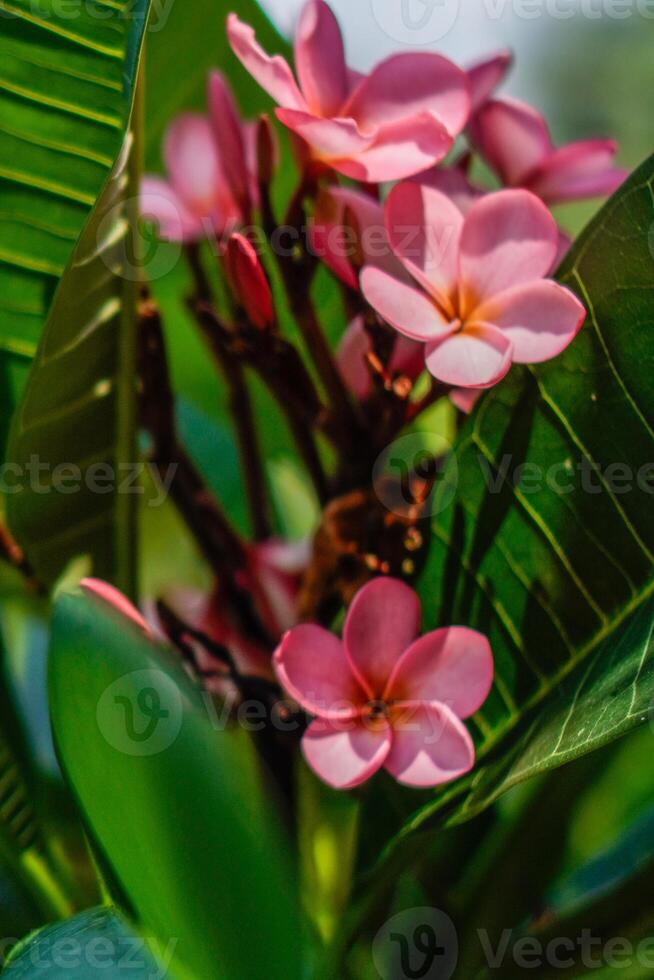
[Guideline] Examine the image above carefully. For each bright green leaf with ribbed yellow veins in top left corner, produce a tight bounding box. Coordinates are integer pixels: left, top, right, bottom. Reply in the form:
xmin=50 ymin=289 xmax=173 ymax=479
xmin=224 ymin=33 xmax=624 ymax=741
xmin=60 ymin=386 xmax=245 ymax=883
xmin=0 ymin=0 xmax=148 ymax=448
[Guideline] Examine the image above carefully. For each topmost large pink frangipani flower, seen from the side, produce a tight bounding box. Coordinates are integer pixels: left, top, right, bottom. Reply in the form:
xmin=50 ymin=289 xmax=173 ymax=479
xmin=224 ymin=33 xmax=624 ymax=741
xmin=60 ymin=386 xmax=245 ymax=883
xmin=227 ymin=0 xmax=470 ymax=182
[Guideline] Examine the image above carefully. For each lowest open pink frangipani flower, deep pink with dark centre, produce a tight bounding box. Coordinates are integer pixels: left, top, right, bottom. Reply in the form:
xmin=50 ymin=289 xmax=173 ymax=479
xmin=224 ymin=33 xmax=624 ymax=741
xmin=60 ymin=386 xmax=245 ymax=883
xmin=273 ymin=578 xmax=493 ymax=789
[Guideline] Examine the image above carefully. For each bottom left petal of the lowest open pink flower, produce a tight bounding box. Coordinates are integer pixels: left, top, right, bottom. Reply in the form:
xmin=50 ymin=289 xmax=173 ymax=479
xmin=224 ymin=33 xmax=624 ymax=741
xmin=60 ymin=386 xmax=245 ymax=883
xmin=302 ymin=718 xmax=392 ymax=789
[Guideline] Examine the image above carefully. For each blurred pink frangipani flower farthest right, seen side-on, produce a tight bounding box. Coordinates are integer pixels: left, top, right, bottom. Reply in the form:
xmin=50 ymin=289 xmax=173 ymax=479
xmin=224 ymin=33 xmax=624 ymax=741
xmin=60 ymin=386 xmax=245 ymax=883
xmin=470 ymin=99 xmax=627 ymax=204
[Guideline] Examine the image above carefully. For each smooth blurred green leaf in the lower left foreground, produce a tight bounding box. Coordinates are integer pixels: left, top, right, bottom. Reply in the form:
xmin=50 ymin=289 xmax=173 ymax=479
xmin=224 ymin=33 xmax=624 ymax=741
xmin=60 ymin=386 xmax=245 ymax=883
xmin=50 ymin=595 xmax=300 ymax=980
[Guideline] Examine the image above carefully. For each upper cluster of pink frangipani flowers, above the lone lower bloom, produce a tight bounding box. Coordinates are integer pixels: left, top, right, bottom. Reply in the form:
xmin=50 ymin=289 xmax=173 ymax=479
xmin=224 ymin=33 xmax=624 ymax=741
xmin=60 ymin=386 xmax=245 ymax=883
xmin=143 ymin=0 xmax=625 ymax=405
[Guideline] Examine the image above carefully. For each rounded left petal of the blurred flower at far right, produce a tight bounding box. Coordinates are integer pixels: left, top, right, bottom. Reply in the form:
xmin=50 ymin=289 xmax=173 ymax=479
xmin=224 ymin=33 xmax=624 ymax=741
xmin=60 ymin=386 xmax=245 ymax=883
xmin=470 ymin=99 xmax=552 ymax=186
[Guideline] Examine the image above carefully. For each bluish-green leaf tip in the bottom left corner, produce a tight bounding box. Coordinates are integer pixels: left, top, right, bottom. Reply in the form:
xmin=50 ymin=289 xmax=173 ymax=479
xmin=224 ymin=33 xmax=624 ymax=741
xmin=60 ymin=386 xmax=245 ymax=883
xmin=2 ymin=908 xmax=173 ymax=980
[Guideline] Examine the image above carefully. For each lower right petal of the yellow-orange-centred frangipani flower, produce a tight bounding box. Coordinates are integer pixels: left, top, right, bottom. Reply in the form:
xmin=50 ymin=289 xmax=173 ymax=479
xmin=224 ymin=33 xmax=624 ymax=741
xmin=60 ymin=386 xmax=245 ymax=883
xmin=474 ymin=279 xmax=586 ymax=364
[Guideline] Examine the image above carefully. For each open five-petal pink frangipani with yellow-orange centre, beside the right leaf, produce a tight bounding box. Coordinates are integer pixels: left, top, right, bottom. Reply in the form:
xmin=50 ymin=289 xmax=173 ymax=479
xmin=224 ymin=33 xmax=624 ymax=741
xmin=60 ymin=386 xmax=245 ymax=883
xmin=361 ymin=181 xmax=586 ymax=388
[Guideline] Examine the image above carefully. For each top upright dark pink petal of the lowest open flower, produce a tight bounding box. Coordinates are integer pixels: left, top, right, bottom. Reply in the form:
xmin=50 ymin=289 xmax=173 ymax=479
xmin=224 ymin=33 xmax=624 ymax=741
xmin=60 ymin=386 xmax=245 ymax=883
xmin=343 ymin=578 xmax=420 ymax=698
